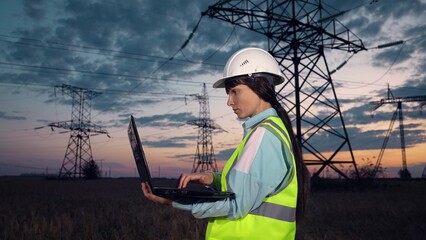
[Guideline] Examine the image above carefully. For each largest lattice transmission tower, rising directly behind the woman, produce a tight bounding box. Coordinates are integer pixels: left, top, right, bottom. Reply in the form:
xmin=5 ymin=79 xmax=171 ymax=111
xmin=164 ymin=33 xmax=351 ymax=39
xmin=202 ymin=0 xmax=366 ymax=178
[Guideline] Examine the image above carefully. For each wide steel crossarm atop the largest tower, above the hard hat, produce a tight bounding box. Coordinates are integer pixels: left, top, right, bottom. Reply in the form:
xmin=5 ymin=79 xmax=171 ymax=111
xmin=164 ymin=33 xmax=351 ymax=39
xmin=202 ymin=0 xmax=367 ymax=53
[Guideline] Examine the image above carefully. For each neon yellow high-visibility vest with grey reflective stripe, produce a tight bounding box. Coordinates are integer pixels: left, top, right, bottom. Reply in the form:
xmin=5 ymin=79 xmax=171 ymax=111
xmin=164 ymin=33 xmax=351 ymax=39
xmin=206 ymin=116 xmax=297 ymax=240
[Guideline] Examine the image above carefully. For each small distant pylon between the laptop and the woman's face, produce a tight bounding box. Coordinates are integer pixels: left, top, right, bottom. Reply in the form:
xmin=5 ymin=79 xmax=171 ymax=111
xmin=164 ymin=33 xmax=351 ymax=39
xmin=187 ymin=83 xmax=220 ymax=173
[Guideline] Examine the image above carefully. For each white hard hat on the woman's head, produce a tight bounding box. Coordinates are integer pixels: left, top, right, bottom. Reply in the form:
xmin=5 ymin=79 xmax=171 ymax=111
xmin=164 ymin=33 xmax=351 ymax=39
xmin=213 ymin=48 xmax=284 ymax=88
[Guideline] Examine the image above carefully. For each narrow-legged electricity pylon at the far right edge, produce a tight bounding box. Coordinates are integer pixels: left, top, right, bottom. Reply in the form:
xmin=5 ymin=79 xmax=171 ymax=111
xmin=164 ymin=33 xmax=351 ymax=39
xmin=370 ymin=86 xmax=426 ymax=178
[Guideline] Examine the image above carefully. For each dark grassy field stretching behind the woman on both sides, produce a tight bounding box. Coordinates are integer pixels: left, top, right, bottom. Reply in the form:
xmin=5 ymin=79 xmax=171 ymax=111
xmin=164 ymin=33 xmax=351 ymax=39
xmin=0 ymin=177 xmax=426 ymax=239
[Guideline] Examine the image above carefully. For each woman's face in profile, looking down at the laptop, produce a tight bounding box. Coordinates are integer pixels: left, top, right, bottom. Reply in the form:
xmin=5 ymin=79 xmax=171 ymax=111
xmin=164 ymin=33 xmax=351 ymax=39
xmin=227 ymin=84 xmax=271 ymax=119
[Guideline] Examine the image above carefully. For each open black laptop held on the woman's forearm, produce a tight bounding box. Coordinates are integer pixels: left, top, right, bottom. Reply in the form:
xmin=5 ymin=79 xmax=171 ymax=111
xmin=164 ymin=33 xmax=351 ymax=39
xmin=127 ymin=116 xmax=234 ymax=202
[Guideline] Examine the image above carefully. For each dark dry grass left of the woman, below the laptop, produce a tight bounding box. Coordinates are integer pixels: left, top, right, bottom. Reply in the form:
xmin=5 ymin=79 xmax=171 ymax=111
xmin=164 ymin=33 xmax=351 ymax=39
xmin=0 ymin=178 xmax=204 ymax=239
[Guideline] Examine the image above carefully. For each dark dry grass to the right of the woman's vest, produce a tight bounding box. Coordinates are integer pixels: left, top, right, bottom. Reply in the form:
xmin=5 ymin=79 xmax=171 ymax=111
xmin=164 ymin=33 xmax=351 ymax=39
xmin=300 ymin=180 xmax=426 ymax=240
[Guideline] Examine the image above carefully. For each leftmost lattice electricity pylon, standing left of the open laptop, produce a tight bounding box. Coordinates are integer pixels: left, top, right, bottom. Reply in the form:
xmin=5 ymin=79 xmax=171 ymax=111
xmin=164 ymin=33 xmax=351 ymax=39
xmin=48 ymin=84 xmax=109 ymax=178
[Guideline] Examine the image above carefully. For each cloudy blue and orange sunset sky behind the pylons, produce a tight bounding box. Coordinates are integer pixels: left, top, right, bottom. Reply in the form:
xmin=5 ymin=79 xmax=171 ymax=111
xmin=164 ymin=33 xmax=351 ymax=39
xmin=0 ymin=0 xmax=426 ymax=177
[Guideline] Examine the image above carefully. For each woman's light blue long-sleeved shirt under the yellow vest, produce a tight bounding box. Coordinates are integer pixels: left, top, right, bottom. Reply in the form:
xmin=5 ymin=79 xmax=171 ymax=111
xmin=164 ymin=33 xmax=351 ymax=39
xmin=173 ymin=108 xmax=291 ymax=219
